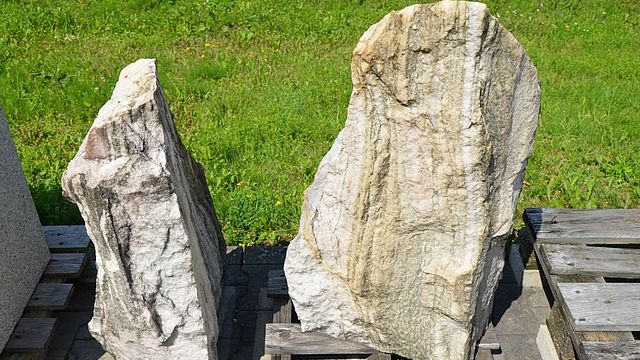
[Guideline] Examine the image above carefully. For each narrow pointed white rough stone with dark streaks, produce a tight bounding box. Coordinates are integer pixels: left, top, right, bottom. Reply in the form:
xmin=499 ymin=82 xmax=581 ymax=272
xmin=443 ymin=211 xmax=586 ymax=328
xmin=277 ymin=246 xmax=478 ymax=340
xmin=62 ymin=59 xmax=225 ymax=359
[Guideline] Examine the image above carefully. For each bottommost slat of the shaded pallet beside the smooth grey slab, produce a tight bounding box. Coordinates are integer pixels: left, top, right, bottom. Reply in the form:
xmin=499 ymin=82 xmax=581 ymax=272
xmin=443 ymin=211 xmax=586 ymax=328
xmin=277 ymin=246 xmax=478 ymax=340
xmin=4 ymin=318 xmax=56 ymax=353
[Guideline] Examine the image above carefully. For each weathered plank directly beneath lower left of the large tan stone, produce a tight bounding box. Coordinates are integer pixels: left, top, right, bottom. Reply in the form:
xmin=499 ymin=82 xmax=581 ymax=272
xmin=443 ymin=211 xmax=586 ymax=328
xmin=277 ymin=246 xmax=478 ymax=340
xmin=264 ymin=324 xmax=375 ymax=355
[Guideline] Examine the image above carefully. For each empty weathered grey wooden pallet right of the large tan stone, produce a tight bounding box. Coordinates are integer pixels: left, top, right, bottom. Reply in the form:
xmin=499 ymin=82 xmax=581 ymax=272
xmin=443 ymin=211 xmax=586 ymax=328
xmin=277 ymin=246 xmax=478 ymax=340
xmin=524 ymin=209 xmax=640 ymax=360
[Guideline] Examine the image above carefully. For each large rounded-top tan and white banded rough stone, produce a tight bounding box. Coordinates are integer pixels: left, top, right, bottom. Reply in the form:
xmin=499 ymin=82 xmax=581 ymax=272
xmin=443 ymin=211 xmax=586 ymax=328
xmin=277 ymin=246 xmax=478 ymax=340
xmin=285 ymin=2 xmax=540 ymax=359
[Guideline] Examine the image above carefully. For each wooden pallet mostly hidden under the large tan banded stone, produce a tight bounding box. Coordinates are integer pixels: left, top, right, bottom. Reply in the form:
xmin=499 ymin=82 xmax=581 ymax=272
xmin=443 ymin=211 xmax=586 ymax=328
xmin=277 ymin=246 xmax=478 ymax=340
xmin=265 ymin=270 xmax=500 ymax=360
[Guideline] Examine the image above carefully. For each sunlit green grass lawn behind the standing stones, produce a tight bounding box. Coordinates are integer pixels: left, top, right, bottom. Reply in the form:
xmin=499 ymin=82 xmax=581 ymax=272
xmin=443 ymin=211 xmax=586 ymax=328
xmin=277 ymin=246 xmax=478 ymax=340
xmin=0 ymin=0 xmax=640 ymax=244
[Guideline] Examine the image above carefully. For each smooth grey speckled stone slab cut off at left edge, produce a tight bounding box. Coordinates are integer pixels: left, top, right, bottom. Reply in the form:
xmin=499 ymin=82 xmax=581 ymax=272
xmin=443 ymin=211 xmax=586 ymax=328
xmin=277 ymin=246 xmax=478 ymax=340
xmin=0 ymin=109 xmax=49 ymax=352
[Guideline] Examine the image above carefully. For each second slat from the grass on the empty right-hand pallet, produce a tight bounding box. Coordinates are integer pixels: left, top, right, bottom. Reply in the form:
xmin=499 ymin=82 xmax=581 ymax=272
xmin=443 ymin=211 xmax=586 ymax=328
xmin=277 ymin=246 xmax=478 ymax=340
xmin=541 ymin=244 xmax=640 ymax=279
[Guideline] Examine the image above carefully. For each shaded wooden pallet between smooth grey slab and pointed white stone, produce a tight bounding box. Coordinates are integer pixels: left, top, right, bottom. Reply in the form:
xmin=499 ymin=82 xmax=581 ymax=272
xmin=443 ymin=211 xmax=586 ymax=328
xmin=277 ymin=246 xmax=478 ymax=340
xmin=0 ymin=225 xmax=89 ymax=360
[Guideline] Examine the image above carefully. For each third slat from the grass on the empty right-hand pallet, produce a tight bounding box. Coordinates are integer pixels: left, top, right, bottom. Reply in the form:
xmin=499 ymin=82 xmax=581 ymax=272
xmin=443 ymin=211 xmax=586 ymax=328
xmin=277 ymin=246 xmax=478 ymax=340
xmin=558 ymin=283 xmax=640 ymax=331
